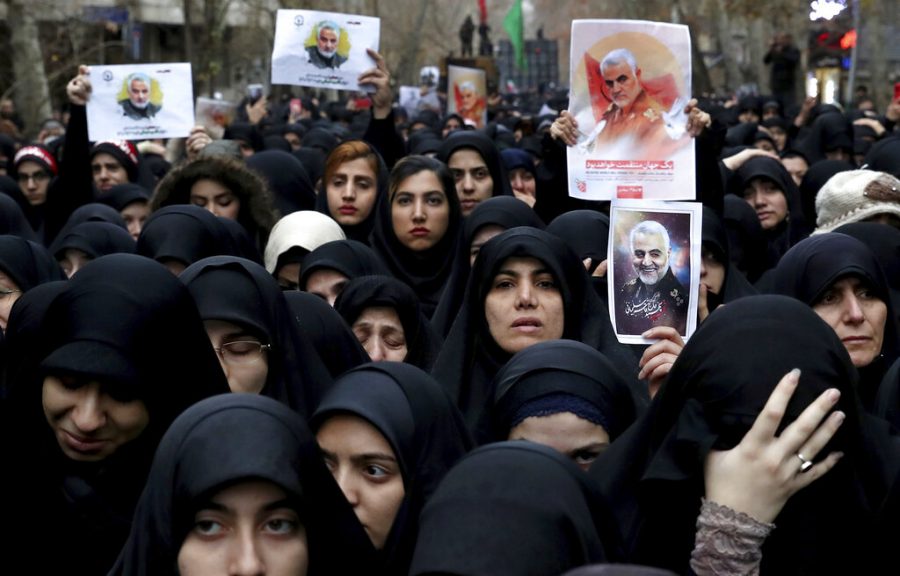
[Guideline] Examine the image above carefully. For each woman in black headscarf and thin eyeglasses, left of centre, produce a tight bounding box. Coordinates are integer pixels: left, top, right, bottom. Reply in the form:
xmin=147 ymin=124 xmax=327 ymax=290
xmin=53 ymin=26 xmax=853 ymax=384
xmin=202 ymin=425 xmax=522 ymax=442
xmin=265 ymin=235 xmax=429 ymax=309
xmin=179 ymin=256 xmax=331 ymax=416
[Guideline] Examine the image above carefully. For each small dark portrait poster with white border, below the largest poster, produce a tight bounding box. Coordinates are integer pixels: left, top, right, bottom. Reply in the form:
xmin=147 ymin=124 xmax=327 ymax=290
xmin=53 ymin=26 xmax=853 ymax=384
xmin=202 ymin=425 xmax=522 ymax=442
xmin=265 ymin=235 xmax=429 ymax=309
xmin=607 ymin=199 xmax=703 ymax=344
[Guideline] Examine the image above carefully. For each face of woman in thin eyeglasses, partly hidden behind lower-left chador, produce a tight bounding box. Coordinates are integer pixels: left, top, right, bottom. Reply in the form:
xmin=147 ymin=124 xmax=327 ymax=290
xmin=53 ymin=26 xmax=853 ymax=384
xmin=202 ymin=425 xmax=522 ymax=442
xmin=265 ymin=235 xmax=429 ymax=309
xmin=203 ymin=320 xmax=269 ymax=394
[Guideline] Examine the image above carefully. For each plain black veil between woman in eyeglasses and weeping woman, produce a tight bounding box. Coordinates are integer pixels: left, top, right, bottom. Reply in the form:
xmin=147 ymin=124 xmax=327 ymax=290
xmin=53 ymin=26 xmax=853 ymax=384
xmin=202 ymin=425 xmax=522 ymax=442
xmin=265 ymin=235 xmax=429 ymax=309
xmin=284 ymin=290 xmax=369 ymax=378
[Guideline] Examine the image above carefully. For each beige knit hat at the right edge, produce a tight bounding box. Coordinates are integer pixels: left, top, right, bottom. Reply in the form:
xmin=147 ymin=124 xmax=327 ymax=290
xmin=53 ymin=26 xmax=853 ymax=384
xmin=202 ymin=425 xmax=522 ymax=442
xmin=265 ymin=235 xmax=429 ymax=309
xmin=813 ymin=170 xmax=900 ymax=234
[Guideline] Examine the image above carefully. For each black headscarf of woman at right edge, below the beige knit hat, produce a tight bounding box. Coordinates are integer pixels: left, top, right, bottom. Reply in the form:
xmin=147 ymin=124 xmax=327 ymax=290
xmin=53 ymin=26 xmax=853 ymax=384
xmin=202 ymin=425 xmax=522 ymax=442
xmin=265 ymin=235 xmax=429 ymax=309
xmin=772 ymin=232 xmax=900 ymax=409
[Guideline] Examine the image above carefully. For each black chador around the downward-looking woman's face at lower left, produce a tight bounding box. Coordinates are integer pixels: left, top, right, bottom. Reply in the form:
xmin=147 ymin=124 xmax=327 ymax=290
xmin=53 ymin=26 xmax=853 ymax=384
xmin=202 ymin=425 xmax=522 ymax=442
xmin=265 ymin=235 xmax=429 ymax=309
xmin=0 ymin=254 xmax=228 ymax=574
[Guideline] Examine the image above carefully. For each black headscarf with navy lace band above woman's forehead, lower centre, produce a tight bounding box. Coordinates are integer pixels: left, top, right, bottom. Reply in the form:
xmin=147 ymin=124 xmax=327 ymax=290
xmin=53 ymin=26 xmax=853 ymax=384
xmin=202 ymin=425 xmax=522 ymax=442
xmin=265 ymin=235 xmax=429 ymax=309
xmin=476 ymin=340 xmax=637 ymax=444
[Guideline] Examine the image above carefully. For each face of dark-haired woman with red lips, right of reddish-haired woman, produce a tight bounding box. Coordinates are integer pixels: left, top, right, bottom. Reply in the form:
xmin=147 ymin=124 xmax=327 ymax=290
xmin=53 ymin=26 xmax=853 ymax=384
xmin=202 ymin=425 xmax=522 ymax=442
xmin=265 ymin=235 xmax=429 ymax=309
xmin=391 ymin=170 xmax=450 ymax=252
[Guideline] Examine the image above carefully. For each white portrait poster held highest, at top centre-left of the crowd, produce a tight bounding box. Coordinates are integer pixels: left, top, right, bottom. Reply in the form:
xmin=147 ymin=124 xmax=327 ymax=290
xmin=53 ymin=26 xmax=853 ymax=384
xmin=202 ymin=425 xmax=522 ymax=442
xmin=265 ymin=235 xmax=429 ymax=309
xmin=272 ymin=10 xmax=381 ymax=92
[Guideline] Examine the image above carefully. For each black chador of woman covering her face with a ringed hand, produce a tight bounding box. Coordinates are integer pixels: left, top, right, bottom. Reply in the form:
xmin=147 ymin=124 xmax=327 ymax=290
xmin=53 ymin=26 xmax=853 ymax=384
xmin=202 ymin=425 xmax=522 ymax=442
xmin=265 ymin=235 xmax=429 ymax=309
xmin=590 ymin=296 xmax=898 ymax=574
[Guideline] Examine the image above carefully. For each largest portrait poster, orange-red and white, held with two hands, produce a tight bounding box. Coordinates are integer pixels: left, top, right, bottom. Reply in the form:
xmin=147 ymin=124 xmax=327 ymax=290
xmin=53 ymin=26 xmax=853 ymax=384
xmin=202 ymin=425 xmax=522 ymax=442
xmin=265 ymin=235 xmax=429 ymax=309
xmin=567 ymin=20 xmax=696 ymax=200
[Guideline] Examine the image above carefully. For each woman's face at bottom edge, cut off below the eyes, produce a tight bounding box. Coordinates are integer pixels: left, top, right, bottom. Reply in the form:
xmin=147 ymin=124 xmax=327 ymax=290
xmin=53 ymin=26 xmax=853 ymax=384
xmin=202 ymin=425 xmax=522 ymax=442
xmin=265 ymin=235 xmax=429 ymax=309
xmin=178 ymin=480 xmax=309 ymax=576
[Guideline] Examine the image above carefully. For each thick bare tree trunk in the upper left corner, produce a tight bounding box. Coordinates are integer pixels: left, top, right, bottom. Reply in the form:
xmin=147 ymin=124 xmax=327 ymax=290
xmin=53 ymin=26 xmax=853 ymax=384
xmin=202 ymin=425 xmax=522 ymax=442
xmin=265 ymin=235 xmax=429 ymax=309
xmin=7 ymin=0 xmax=51 ymax=136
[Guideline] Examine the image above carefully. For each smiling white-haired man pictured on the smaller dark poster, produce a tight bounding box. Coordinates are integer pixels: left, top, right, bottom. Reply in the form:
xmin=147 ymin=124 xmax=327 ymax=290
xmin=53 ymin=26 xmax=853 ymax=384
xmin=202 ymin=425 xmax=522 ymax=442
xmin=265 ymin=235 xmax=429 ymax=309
xmin=616 ymin=220 xmax=688 ymax=334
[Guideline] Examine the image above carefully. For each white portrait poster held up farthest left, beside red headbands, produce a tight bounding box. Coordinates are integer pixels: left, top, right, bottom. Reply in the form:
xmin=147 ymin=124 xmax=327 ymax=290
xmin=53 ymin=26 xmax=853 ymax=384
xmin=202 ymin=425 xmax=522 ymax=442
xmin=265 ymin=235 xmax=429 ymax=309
xmin=87 ymin=63 xmax=194 ymax=142
